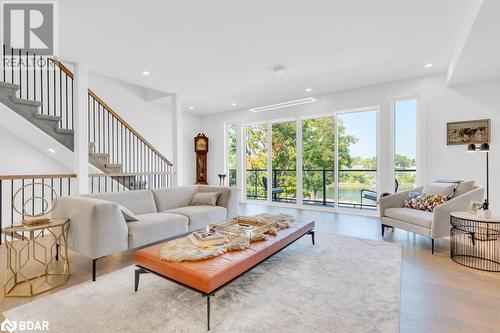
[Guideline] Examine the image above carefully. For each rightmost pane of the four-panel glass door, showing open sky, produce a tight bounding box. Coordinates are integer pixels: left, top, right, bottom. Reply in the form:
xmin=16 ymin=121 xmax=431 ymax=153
xmin=337 ymin=110 xmax=377 ymax=209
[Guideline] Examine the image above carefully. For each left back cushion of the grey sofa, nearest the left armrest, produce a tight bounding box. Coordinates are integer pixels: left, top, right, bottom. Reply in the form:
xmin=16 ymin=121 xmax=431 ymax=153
xmin=82 ymin=190 xmax=157 ymax=214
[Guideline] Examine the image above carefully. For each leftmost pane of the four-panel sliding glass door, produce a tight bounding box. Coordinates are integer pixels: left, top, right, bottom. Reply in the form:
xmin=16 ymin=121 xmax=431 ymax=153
xmin=245 ymin=123 xmax=268 ymax=200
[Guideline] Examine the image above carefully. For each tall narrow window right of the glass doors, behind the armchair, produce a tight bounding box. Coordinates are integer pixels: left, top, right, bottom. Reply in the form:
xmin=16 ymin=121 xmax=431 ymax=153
xmin=394 ymin=98 xmax=417 ymax=191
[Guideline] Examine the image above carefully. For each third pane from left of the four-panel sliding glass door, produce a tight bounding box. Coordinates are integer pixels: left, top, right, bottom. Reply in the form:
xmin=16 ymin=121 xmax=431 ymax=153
xmin=302 ymin=117 xmax=335 ymax=207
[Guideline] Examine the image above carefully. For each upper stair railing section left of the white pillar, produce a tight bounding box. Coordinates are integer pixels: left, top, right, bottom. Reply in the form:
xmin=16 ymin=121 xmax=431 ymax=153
xmin=1 ymin=44 xmax=74 ymax=130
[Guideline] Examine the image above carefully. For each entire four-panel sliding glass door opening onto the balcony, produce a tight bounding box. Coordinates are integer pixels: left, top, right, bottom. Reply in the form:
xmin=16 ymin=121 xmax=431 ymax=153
xmin=244 ymin=109 xmax=378 ymax=210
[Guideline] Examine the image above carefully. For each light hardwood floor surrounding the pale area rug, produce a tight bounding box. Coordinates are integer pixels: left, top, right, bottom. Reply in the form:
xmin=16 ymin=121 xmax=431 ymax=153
xmin=0 ymin=204 xmax=500 ymax=333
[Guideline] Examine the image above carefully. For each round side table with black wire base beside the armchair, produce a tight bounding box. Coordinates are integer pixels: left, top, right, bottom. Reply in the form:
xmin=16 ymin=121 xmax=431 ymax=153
xmin=450 ymin=212 xmax=500 ymax=272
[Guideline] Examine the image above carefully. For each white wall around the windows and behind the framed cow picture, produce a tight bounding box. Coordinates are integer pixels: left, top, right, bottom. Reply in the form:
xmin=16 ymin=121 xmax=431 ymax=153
xmin=201 ymin=74 xmax=500 ymax=209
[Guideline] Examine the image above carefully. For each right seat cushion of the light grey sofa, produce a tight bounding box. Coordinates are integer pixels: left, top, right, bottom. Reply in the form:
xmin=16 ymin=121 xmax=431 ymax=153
xmin=165 ymin=206 xmax=227 ymax=230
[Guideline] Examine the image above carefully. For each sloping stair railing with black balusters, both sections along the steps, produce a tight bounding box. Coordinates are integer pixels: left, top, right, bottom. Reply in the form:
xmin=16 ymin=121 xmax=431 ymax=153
xmin=1 ymin=45 xmax=173 ymax=192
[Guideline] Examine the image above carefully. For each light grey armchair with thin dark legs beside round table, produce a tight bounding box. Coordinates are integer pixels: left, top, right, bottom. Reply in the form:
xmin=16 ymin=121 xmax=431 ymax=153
xmin=379 ymin=182 xmax=484 ymax=254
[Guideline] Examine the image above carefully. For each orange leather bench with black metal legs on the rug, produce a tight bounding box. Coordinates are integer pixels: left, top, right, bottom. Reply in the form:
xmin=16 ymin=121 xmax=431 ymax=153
xmin=134 ymin=221 xmax=314 ymax=330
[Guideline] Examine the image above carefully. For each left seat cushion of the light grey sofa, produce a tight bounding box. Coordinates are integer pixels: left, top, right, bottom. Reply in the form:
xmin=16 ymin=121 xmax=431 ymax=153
xmin=127 ymin=213 xmax=189 ymax=249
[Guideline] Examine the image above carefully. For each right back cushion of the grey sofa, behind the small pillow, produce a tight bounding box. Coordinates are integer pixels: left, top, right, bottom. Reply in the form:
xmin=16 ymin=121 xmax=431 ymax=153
xmin=151 ymin=186 xmax=198 ymax=212
